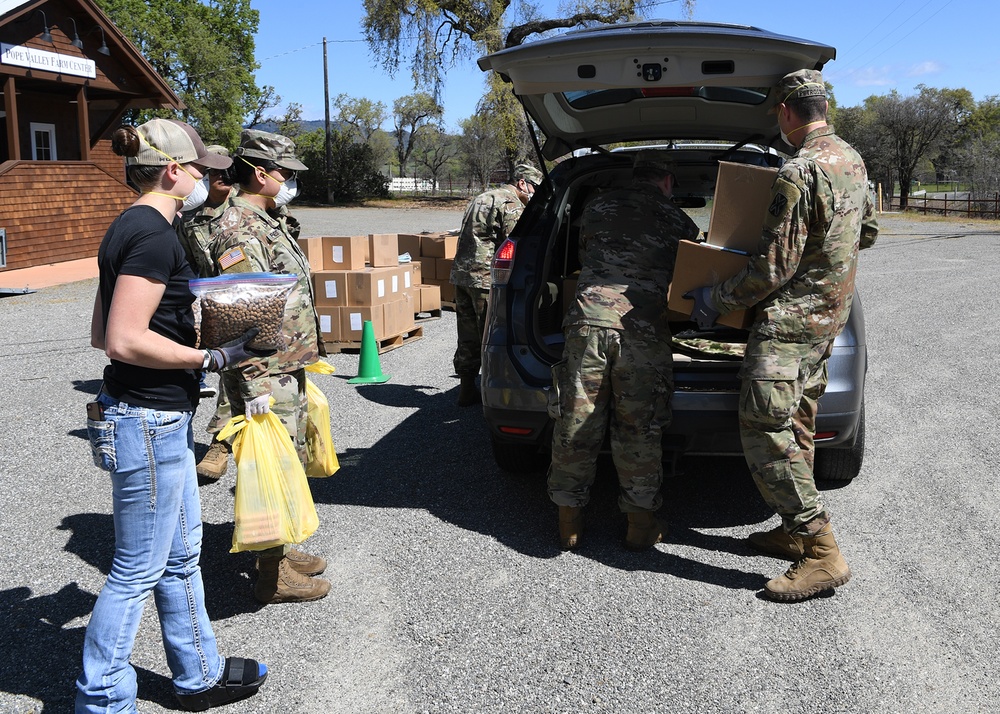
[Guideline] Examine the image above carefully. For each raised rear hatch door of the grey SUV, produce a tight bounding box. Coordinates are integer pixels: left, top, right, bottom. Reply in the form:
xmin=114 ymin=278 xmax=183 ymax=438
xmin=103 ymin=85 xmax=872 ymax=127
xmin=478 ymin=20 xmax=837 ymax=160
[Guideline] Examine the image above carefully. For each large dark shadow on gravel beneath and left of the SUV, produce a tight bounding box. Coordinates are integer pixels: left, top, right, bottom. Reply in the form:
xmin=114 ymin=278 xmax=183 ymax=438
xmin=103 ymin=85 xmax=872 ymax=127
xmin=310 ymin=383 xmax=772 ymax=589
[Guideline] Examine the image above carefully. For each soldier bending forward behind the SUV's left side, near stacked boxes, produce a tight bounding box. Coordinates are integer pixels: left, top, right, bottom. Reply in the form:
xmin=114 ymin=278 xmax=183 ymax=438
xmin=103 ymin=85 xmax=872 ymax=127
xmin=451 ymin=164 xmax=542 ymax=407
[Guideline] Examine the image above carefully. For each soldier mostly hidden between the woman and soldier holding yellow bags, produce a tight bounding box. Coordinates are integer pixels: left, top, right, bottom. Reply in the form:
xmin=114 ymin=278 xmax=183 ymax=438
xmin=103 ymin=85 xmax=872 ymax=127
xmin=177 ymin=144 xmax=236 ymax=481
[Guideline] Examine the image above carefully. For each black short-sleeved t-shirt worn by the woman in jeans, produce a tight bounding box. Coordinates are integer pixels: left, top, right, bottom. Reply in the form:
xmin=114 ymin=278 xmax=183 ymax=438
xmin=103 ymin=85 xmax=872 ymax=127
xmin=97 ymin=206 xmax=199 ymax=411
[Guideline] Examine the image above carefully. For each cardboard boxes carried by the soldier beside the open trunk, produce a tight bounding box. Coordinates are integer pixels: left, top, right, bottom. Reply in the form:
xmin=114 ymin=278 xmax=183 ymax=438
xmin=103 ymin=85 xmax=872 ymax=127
xmin=667 ymin=161 xmax=778 ymax=328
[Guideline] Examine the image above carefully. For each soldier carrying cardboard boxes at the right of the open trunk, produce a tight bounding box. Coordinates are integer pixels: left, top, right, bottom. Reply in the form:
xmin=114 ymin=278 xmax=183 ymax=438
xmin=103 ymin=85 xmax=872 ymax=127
xmin=690 ymin=70 xmax=878 ymax=601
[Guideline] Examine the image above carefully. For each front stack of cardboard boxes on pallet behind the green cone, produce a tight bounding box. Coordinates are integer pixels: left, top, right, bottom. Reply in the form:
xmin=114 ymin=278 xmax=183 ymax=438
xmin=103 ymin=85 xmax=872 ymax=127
xmin=299 ymin=233 xmax=441 ymax=343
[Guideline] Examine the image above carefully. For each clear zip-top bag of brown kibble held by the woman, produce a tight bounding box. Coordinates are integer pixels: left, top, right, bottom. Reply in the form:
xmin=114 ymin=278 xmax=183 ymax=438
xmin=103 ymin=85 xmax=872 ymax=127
xmin=189 ymin=273 xmax=298 ymax=350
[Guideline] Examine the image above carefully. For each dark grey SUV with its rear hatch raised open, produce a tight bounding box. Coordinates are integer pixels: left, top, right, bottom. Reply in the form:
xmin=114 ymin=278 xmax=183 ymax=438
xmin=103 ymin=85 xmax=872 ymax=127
xmin=479 ymin=21 xmax=868 ymax=481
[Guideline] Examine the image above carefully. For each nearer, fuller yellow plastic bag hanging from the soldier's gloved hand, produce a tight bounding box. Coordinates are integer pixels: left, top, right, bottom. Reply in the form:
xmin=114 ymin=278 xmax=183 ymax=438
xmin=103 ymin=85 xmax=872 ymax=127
xmin=218 ymin=412 xmax=319 ymax=553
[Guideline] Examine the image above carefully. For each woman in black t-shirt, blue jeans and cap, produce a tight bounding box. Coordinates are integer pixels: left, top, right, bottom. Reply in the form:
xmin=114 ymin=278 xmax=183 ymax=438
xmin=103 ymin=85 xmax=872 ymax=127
xmin=76 ymin=119 xmax=267 ymax=713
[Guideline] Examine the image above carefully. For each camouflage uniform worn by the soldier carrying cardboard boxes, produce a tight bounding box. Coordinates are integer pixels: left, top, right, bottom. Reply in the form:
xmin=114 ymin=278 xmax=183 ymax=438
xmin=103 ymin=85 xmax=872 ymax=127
xmin=712 ymin=126 xmax=878 ymax=532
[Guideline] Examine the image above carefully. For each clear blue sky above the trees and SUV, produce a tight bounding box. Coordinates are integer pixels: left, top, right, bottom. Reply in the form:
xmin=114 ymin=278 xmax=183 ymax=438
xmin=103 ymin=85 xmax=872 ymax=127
xmin=251 ymin=0 xmax=1000 ymax=130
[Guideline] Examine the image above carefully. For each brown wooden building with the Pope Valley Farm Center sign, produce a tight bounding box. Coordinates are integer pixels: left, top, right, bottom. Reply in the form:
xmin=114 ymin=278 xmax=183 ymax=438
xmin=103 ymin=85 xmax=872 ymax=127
xmin=0 ymin=0 xmax=183 ymax=272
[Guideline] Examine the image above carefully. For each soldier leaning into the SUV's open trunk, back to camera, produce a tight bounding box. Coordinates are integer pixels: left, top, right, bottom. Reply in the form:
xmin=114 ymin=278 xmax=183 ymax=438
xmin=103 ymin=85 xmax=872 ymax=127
xmin=548 ymin=150 xmax=698 ymax=550
